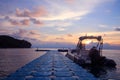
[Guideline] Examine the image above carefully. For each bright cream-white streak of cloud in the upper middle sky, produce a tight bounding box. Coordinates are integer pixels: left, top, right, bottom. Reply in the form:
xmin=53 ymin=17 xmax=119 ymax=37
xmin=39 ymin=10 xmax=89 ymax=21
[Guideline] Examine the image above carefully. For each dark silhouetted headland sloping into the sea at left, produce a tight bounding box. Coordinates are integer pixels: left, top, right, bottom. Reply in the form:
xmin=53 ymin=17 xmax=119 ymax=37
xmin=0 ymin=35 xmax=32 ymax=48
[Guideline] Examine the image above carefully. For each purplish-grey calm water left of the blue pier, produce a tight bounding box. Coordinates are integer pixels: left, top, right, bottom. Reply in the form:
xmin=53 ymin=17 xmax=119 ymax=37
xmin=0 ymin=49 xmax=45 ymax=79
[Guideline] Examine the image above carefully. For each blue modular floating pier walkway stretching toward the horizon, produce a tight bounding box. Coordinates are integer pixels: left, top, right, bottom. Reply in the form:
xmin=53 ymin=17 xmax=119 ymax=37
xmin=5 ymin=51 xmax=97 ymax=80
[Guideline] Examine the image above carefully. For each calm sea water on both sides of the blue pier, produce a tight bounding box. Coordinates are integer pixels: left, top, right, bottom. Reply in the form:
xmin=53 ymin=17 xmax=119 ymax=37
xmin=0 ymin=48 xmax=120 ymax=80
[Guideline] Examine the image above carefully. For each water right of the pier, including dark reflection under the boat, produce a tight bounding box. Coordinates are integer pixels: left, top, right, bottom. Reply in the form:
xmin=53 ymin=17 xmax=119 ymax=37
xmin=63 ymin=50 xmax=120 ymax=80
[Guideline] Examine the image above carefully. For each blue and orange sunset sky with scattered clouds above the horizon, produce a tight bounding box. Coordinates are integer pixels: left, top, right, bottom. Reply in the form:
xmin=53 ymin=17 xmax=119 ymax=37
xmin=0 ymin=0 xmax=120 ymax=49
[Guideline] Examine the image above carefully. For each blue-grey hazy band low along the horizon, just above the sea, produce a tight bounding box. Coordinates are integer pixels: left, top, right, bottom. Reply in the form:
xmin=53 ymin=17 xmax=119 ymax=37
xmin=31 ymin=41 xmax=120 ymax=50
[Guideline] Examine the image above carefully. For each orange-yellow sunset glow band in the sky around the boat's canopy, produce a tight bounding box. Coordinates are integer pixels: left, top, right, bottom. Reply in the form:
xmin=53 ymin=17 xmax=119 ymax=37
xmin=44 ymin=31 xmax=120 ymax=45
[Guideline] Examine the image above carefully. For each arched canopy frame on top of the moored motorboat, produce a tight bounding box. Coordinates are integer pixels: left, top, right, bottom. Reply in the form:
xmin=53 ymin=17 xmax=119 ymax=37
xmin=76 ymin=36 xmax=103 ymax=56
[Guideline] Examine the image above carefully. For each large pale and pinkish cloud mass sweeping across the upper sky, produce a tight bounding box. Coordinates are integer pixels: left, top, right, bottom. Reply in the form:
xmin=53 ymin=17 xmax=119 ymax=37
xmin=0 ymin=0 xmax=113 ymax=31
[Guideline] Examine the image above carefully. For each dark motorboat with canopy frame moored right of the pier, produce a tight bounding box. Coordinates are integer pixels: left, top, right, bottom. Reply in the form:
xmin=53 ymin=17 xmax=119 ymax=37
xmin=66 ymin=36 xmax=116 ymax=67
